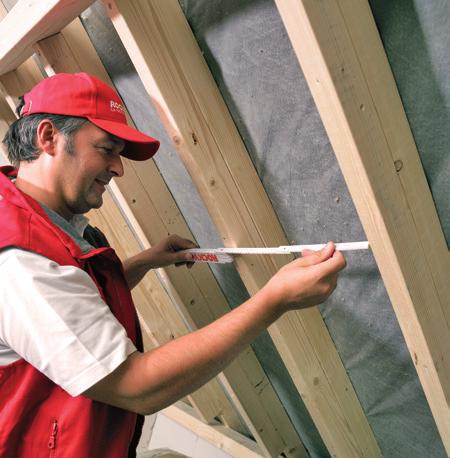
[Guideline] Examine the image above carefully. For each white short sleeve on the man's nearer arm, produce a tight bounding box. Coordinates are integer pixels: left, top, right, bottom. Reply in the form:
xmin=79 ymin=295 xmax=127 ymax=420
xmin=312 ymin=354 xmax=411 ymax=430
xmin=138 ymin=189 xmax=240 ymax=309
xmin=0 ymin=249 xmax=136 ymax=396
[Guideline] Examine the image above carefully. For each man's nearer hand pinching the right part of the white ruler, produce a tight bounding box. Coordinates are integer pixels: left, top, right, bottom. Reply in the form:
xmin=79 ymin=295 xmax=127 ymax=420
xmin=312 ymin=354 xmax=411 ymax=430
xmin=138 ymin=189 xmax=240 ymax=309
xmin=261 ymin=242 xmax=346 ymax=313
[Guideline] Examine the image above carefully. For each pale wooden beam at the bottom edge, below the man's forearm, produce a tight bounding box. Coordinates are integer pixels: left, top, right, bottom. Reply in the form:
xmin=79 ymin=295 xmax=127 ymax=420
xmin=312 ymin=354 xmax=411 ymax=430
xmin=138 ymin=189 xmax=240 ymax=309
xmin=161 ymin=402 xmax=263 ymax=458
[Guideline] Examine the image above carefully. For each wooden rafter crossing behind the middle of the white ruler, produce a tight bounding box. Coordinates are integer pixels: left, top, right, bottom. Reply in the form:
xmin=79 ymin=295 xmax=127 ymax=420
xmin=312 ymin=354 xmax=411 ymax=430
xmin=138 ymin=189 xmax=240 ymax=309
xmin=104 ymin=0 xmax=380 ymax=457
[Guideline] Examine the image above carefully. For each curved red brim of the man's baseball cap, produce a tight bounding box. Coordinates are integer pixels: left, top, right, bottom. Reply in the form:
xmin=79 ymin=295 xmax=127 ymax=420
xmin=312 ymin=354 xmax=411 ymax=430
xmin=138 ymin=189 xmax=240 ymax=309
xmin=88 ymin=117 xmax=159 ymax=161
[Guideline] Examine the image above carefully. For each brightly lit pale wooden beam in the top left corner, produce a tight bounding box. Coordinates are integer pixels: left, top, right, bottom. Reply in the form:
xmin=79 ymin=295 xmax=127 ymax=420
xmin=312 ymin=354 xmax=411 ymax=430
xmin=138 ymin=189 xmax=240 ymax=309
xmin=0 ymin=0 xmax=93 ymax=75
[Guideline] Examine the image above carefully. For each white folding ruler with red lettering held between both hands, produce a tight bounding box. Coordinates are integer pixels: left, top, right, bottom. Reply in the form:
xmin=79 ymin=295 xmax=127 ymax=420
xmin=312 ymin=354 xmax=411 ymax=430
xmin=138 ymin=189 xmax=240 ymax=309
xmin=184 ymin=241 xmax=369 ymax=264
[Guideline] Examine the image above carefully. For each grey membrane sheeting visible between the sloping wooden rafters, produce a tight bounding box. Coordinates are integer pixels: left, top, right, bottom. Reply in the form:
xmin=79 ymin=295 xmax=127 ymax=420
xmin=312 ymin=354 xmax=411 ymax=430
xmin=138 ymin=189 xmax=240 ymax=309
xmin=62 ymin=0 xmax=450 ymax=458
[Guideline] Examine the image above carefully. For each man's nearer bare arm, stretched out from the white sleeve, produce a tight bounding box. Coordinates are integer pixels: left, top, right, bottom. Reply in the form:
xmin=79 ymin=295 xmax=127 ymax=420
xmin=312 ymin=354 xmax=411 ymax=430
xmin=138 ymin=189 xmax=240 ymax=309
xmin=84 ymin=244 xmax=345 ymax=414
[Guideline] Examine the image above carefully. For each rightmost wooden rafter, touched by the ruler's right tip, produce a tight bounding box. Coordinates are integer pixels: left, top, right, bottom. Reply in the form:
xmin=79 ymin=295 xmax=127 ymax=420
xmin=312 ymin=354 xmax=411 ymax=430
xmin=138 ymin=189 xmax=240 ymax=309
xmin=276 ymin=0 xmax=450 ymax=454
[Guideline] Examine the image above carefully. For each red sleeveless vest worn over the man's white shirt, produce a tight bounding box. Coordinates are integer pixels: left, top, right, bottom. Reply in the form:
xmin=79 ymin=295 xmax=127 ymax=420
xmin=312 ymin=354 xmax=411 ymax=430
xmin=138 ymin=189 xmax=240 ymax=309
xmin=0 ymin=167 xmax=142 ymax=458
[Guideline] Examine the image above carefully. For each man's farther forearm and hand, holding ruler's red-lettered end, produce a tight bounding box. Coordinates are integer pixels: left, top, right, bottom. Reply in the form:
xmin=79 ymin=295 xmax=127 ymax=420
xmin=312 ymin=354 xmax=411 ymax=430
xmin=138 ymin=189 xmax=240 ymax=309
xmin=123 ymin=235 xmax=197 ymax=289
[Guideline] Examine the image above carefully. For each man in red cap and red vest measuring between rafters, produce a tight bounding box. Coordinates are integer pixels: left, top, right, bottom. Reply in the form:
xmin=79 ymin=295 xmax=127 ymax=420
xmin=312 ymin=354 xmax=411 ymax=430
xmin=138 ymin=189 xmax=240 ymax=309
xmin=0 ymin=73 xmax=345 ymax=458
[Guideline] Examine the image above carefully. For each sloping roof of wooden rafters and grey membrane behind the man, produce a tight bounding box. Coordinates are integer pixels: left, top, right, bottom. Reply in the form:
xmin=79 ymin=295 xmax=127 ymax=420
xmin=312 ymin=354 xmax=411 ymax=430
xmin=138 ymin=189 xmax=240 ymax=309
xmin=0 ymin=0 xmax=450 ymax=458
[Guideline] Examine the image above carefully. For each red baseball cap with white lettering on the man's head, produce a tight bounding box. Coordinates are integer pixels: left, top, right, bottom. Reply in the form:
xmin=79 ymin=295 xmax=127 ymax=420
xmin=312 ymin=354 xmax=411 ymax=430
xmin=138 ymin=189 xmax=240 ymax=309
xmin=20 ymin=73 xmax=159 ymax=161
